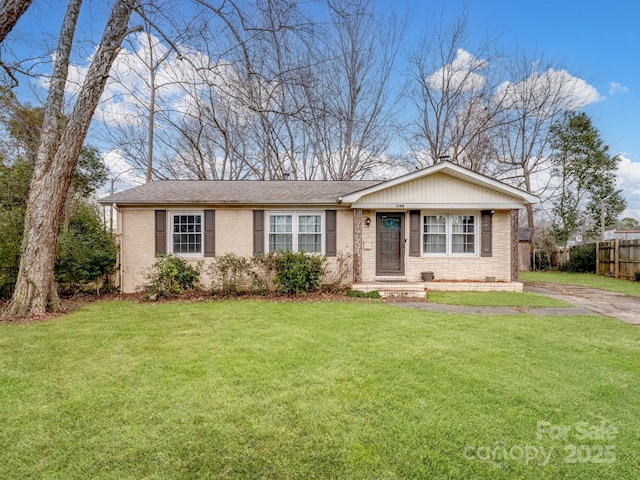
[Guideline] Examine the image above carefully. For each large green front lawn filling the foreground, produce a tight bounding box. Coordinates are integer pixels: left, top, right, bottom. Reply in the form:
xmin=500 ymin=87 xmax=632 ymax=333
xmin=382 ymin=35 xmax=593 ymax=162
xmin=0 ymin=301 xmax=640 ymax=480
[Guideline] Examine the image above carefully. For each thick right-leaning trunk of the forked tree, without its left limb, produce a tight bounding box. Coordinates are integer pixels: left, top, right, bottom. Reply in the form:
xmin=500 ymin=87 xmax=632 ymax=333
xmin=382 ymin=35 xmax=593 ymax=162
xmin=7 ymin=0 xmax=133 ymax=315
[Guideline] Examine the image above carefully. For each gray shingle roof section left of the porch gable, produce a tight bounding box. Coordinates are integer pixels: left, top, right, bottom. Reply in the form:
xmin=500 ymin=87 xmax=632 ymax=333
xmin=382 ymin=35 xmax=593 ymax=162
xmin=99 ymin=180 xmax=380 ymax=205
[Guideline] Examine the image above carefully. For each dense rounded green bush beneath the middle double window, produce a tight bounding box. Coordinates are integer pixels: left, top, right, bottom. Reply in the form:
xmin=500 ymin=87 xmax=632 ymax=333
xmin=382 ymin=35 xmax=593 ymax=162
xmin=275 ymin=252 xmax=326 ymax=294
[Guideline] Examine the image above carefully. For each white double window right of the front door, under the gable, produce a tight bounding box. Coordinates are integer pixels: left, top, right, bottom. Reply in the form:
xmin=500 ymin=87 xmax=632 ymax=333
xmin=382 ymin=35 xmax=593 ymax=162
xmin=422 ymin=215 xmax=476 ymax=255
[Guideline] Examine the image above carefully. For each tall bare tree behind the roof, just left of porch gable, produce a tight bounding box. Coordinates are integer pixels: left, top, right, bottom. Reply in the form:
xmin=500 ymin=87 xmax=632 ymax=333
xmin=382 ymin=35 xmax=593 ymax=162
xmin=305 ymin=0 xmax=404 ymax=180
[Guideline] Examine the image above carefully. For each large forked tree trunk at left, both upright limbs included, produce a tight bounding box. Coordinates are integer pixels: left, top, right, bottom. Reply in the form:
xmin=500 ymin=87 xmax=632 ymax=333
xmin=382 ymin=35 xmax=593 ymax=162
xmin=7 ymin=0 xmax=134 ymax=315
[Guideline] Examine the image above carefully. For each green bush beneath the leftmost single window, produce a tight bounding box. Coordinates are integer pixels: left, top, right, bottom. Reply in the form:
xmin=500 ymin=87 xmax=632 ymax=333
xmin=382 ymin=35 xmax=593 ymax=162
xmin=147 ymin=254 xmax=202 ymax=300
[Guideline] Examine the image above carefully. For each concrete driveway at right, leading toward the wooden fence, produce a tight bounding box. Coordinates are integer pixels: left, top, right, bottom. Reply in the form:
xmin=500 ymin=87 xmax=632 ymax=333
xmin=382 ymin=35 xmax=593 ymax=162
xmin=524 ymin=283 xmax=640 ymax=325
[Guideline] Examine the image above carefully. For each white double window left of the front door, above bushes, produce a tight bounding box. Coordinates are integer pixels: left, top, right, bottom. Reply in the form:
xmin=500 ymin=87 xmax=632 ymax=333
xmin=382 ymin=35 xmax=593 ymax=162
xmin=268 ymin=213 xmax=322 ymax=253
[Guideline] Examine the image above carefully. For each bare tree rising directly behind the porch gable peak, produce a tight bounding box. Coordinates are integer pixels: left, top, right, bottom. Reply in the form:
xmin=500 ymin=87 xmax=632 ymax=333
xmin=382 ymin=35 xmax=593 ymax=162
xmin=408 ymin=12 xmax=504 ymax=173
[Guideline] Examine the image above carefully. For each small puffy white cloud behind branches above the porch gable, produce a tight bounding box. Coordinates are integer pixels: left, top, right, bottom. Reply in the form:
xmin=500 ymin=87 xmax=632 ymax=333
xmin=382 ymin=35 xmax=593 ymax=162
xmin=427 ymin=48 xmax=487 ymax=92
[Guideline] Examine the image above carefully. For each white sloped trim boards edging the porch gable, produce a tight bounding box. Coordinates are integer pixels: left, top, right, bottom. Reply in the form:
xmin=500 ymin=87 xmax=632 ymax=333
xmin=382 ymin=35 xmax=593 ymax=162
xmin=341 ymin=161 xmax=540 ymax=205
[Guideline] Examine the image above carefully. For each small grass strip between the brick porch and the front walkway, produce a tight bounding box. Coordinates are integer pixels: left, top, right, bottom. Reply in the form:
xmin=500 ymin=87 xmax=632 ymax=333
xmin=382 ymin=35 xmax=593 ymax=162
xmin=428 ymin=292 xmax=570 ymax=307
